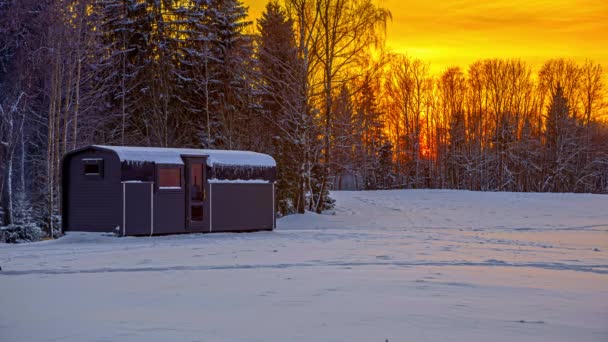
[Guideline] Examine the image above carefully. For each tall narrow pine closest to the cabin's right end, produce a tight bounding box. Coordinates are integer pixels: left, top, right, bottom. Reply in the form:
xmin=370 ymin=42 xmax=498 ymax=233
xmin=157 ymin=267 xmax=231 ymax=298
xmin=257 ymin=2 xmax=304 ymax=215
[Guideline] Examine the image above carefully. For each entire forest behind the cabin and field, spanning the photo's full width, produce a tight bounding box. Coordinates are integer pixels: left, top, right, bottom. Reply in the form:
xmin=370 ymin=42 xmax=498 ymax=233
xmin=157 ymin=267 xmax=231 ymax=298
xmin=0 ymin=0 xmax=608 ymax=239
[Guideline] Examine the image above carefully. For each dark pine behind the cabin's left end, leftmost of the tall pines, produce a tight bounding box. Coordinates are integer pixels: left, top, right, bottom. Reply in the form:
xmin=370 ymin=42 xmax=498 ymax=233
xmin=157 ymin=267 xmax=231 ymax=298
xmin=93 ymin=0 xmax=152 ymax=145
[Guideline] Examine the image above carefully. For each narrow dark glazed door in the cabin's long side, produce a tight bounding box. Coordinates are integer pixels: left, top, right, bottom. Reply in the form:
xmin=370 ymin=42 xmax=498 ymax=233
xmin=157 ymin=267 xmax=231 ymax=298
xmin=186 ymin=158 xmax=209 ymax=232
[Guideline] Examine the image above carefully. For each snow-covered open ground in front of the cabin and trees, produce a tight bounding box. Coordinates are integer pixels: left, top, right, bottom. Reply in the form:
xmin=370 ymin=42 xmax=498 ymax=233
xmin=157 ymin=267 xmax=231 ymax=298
xmin=0 ymin=190 xmax=608 ymax=342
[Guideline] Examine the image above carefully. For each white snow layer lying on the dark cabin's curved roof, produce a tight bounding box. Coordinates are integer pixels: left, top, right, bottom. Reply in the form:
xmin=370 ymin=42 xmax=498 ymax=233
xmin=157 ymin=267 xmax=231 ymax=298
xmin=93 ymin=145 xmax=276 ymax=167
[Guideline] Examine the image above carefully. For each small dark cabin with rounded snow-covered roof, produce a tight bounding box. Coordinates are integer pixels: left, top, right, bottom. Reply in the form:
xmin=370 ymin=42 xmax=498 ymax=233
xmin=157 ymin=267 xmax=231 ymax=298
xmin=62 ymin=145 xmax=276 ymax=235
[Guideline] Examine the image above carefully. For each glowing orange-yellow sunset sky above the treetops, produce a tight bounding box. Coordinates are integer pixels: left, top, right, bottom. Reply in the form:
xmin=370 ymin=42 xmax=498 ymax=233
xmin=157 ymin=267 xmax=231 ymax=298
xmin=243 ymin=0 xmax=608 ymax=72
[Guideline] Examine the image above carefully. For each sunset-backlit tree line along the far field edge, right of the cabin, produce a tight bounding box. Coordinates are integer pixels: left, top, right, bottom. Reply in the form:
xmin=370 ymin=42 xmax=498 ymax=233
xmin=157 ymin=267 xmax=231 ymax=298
xmin=336 ymin=56 xmax=608 ymax=193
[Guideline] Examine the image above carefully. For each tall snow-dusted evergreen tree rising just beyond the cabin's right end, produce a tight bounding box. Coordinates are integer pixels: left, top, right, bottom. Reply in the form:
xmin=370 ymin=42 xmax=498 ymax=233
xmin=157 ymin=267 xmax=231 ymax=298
xmin=257 ymin=2 xmax=320 ymax=214
